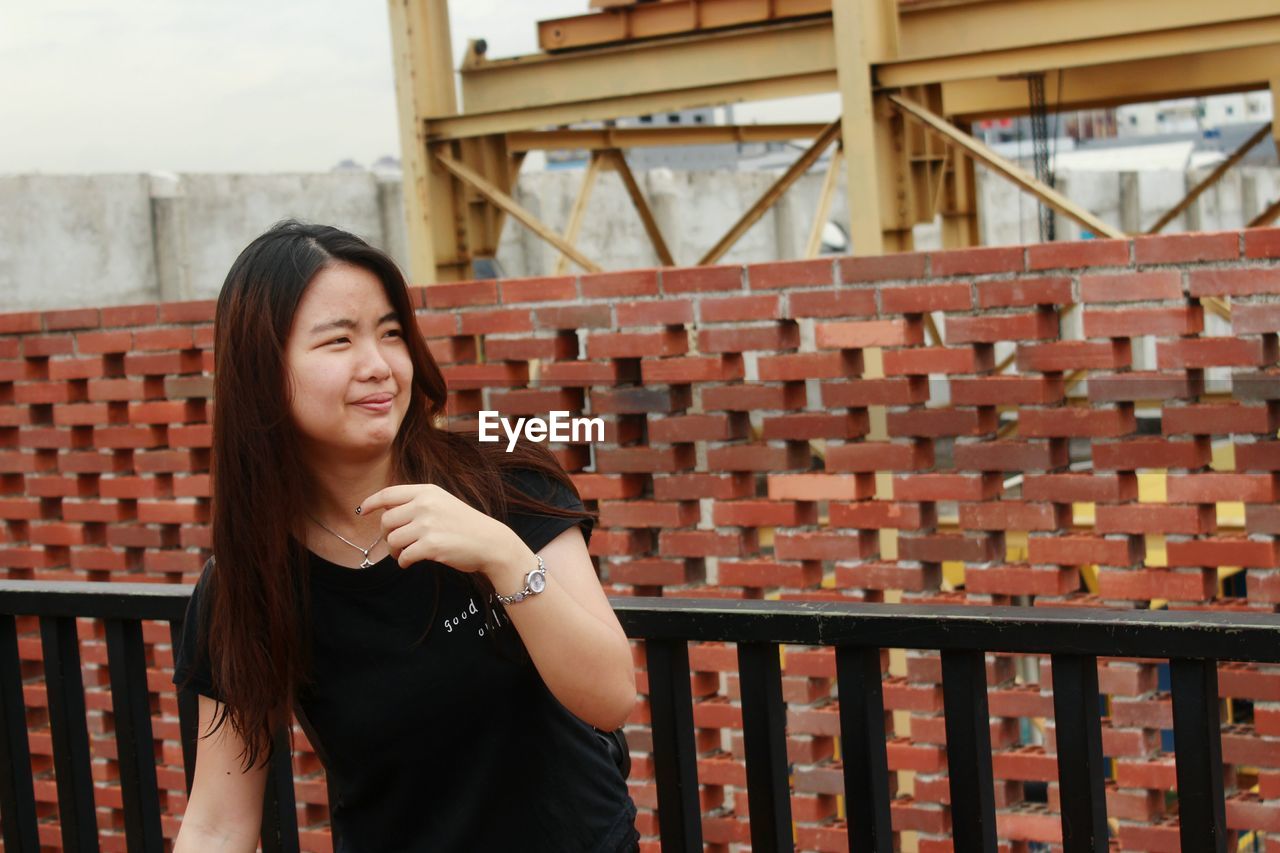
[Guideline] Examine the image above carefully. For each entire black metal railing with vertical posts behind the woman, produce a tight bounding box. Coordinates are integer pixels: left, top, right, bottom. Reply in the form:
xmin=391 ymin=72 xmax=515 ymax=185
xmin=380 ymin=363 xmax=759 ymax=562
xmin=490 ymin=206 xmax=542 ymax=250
xmin=0 ymin=580 xmax=1280 ymax=853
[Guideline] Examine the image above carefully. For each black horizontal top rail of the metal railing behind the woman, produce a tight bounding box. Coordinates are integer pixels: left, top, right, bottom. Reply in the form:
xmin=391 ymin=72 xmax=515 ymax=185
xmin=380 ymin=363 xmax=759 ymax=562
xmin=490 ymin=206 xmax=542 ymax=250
xmin=0 ymin=580 xmax=1280 ymax=663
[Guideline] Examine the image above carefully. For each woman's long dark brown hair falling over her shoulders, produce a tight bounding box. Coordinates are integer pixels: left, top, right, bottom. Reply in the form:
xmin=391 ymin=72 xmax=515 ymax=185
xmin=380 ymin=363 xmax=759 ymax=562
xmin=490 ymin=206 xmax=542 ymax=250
xmin=185 ymin=220 xmax=594 ymax=770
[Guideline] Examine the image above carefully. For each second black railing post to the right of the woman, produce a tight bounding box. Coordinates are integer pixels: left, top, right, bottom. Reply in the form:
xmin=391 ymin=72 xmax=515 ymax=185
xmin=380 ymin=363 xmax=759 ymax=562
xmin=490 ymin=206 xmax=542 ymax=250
xmin=737 ymin=643 xmax=795 ymax=853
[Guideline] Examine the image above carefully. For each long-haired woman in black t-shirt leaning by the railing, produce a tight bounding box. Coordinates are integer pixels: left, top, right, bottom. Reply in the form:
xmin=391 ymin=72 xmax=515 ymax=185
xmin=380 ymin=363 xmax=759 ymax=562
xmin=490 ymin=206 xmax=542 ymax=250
xmin=174 ymin=222 xmax=639 ymax=853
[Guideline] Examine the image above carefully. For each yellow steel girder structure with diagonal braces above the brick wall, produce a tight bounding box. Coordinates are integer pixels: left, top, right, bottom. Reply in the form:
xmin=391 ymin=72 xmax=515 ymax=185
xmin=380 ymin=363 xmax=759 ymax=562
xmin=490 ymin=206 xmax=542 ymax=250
xmin=389 ymin=0 xmax=1280 ymax=283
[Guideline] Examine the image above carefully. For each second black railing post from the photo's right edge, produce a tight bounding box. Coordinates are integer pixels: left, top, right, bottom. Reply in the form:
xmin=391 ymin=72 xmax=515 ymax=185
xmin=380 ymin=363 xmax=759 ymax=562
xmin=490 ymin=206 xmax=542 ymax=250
xmin=1052 ymin=654 xmax=1107 ymax=853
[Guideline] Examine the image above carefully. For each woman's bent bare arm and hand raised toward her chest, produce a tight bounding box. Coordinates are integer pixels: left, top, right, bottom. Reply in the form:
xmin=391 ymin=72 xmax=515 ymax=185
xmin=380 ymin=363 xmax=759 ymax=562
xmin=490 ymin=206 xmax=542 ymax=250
xmin=361 ymin=484 xmax=636 ymax=730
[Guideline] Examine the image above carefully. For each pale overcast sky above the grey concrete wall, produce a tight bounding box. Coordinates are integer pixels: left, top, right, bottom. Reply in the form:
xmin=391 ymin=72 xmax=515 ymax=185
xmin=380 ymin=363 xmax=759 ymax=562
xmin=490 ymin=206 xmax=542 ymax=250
xmin=0 ymin=0 xmax=835 ymax=174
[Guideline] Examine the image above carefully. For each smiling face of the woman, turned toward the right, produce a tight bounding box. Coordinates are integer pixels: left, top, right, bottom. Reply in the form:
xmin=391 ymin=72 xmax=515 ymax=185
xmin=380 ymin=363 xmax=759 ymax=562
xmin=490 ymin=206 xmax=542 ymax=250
xmin=284 ymin=263 xmax=413 ymax=460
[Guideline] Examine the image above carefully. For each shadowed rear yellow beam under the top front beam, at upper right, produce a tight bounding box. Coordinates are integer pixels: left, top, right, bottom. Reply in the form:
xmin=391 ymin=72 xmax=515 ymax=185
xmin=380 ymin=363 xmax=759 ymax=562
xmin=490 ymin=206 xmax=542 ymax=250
xmin=942 ymin=45 xmax=1280 ymax=119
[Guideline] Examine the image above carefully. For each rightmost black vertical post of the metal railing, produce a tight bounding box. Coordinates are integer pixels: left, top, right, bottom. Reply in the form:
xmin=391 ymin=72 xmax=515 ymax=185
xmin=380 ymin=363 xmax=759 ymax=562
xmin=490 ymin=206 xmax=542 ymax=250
xmin=1172 ymin=658 xmax=1228 ymax=853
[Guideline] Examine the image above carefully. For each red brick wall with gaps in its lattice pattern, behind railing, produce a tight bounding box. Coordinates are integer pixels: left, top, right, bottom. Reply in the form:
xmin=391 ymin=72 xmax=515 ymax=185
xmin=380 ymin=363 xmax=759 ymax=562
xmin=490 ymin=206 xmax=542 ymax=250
xmin=0 ymin=229 xmax=1280 ymax=850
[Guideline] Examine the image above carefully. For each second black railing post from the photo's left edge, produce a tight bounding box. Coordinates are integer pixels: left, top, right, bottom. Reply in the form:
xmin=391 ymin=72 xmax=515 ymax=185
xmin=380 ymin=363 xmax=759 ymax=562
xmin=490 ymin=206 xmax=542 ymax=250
xmin=40 ymin=616 xmax=99 ymax=853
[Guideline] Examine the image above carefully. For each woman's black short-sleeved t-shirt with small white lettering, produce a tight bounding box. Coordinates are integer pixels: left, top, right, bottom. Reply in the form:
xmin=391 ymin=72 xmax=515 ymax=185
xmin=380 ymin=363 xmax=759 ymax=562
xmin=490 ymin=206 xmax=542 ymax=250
xmin=173 ymin=470 xmax=639 ymax=853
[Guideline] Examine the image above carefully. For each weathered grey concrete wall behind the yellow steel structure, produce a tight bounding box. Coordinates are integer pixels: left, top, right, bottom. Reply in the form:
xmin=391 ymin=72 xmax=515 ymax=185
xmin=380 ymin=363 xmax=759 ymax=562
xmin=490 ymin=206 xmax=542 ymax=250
xmin=0 ymin=168 xmax=1280 ymax=310
